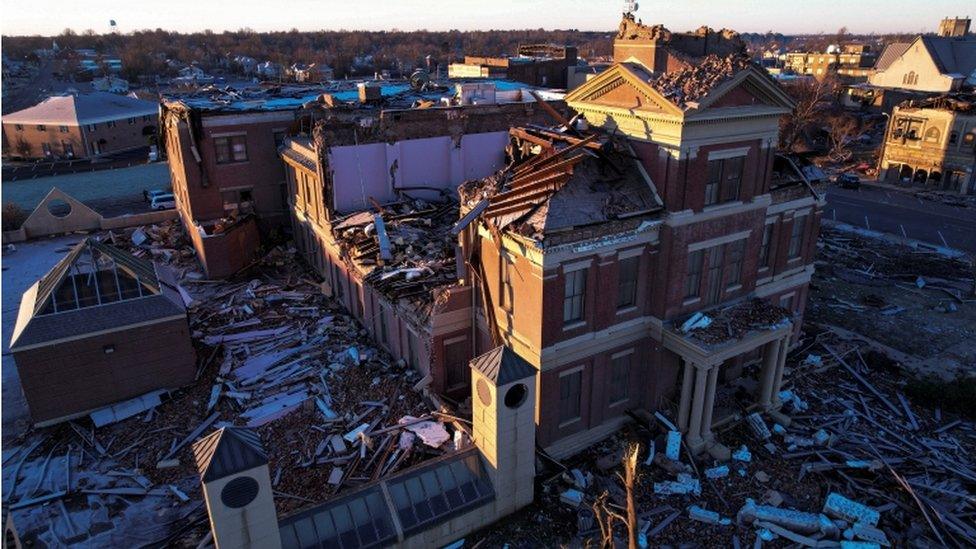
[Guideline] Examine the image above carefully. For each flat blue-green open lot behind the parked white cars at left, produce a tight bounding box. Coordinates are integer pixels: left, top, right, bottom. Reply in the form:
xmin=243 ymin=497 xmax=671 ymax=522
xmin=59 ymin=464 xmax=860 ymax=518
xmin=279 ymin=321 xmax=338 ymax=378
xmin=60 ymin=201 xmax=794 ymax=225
xmin=2 ymin=162 xmax=170 ymax=217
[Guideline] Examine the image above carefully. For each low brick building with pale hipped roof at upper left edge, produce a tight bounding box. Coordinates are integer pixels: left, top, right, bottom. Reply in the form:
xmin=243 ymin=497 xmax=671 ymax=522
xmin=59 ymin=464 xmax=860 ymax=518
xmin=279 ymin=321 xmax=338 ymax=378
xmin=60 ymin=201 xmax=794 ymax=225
xmin=3 ymin=92 xmax=159 ymax=159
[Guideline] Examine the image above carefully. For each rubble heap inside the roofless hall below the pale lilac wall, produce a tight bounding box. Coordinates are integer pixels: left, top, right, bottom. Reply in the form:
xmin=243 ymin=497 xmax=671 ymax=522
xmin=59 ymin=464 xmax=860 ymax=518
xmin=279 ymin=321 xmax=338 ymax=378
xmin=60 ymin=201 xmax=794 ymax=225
xmin=332 ymin=198 xmax=458 ymax=315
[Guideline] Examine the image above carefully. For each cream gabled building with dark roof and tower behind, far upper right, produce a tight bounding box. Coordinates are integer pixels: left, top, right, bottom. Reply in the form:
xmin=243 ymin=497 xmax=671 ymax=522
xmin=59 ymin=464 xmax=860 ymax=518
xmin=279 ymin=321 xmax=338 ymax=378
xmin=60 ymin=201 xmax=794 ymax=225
xmin=868 ymin=19 xmax=976 ymax=93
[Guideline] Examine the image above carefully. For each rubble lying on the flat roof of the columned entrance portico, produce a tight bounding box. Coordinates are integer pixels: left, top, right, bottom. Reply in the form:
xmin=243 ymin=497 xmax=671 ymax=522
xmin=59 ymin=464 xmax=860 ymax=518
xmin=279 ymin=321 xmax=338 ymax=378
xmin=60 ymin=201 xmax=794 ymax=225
xmin=681 ymin=299 xmax=792 ymax=345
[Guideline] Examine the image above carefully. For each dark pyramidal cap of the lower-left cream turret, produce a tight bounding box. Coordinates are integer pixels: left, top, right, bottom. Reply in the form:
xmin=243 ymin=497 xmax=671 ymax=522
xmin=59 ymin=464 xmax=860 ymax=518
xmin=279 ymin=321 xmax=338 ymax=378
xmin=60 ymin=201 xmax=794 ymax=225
xmin=193 ymin=427 xmax=268 ymax=482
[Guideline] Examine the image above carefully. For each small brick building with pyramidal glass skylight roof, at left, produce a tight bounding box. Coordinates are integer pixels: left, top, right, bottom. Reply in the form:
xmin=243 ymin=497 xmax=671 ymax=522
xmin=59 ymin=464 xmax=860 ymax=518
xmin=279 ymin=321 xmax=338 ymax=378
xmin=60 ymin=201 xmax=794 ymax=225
xmin=10 ymin=237 xmax=196 ymax=425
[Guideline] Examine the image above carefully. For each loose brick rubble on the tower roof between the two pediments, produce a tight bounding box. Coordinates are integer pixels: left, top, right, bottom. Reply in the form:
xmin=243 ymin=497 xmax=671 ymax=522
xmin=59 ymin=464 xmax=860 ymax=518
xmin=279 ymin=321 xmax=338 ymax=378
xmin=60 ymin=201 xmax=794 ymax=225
xmin=650 ymin=55 xmax=752 ymax=107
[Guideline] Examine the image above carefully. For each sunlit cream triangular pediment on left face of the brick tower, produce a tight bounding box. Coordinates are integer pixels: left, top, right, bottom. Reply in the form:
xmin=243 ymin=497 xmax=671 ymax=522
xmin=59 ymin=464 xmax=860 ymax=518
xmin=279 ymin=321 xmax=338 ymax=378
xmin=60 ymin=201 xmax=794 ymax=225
xmin=566 ymin=63 xmax=682 ymax=115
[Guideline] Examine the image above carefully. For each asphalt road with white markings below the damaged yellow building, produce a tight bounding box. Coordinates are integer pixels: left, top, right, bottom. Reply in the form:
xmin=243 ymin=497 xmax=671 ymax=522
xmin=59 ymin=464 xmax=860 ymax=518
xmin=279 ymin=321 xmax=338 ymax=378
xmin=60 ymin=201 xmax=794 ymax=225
xmin=824 ymin=186 xmax=976 ymax=253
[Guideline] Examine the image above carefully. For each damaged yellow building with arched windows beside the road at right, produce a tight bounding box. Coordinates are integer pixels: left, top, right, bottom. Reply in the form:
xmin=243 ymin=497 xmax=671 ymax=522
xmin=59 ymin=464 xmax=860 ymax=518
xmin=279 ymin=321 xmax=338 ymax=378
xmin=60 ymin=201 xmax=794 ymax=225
xmin=880 ymin=94 xmax=976 ymax=194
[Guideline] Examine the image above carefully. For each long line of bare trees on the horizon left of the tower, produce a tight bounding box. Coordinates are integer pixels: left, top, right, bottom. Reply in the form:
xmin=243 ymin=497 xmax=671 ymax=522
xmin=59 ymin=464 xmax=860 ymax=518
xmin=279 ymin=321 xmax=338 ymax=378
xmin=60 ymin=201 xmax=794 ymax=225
xmin=2 ymin=29 xmax=613 ymax=79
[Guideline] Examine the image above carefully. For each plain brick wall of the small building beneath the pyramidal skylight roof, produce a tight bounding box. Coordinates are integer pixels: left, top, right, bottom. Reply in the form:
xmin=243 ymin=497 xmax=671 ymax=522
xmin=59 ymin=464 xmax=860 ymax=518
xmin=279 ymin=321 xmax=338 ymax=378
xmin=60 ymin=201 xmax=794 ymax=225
xmin=14 ymin=319 xmax=196 ymax=422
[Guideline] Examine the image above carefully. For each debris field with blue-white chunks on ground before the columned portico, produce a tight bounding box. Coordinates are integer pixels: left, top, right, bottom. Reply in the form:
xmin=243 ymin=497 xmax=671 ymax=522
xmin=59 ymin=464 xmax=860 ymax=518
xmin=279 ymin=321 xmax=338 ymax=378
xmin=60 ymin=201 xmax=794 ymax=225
xmin=471 ymin=332 xmax=976 ymax=547
